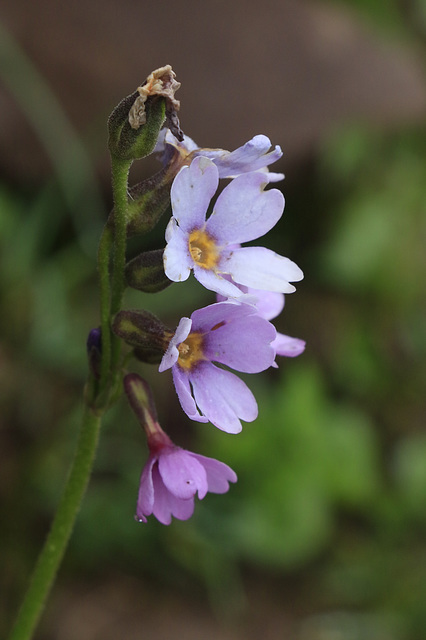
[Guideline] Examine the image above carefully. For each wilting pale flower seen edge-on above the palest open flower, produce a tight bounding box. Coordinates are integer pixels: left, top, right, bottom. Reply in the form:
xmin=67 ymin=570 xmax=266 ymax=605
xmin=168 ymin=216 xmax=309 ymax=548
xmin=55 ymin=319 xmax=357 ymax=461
xmin=155 ymin=129 xmax=284 ymax=182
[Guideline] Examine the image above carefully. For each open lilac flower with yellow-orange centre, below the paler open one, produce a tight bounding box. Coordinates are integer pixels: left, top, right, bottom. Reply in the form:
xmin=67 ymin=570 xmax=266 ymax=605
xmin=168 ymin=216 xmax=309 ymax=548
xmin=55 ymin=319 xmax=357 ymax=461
xmin=159 ymin=302 xmax=276 ymax=433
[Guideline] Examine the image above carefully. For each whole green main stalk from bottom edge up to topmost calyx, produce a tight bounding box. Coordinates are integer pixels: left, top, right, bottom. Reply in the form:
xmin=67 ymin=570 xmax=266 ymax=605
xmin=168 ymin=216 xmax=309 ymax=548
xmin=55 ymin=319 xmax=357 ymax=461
xmin=10 ymin=68 xmax=178 ymax=640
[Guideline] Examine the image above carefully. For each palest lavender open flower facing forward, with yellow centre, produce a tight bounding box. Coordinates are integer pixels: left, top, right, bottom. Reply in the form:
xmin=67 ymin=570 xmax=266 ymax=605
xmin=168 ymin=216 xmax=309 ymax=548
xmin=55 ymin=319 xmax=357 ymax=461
xmin=163 ymin=156 xmax=303 ymax=301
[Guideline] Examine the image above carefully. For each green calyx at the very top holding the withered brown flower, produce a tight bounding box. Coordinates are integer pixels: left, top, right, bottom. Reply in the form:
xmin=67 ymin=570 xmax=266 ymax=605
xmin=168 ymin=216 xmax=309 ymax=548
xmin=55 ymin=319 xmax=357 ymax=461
xmin=108 ymin=91 xmax=166 ymax=160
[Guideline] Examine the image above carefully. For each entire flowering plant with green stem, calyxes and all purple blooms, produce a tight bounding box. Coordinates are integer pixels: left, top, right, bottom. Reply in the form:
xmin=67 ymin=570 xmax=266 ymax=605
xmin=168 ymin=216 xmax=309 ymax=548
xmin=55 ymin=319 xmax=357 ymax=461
xmin=10 ymin=65 xmax=305 ymax=640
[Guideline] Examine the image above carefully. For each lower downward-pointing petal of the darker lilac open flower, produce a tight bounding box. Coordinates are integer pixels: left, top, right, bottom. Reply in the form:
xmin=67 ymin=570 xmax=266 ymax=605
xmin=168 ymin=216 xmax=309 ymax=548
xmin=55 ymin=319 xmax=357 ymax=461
xmin=190 ymin=362 xmax=258 ymax=433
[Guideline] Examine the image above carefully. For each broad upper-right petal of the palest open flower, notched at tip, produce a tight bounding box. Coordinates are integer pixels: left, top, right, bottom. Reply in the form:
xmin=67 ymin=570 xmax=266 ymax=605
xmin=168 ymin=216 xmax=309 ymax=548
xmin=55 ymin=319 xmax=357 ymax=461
xmin=206 ymin=172 xmax=284 ymax=245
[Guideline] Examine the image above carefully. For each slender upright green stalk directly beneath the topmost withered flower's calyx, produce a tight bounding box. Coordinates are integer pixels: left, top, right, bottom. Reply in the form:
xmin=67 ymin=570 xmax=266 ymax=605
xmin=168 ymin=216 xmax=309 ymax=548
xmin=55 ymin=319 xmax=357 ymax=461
xmin=110 ymin=156 xmax=132 ymax=371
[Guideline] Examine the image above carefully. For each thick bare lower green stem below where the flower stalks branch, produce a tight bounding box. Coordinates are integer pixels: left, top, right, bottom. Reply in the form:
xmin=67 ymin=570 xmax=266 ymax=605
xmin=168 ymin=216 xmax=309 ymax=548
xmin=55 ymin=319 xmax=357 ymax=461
xmin=10 ymin=408 xmax=101 ymax=640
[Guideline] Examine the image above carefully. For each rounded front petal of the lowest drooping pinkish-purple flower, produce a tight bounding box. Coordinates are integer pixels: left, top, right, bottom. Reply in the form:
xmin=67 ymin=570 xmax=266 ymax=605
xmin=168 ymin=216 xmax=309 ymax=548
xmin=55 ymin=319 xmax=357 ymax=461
xmin=158 ymin=447 xmax=208 ymax=500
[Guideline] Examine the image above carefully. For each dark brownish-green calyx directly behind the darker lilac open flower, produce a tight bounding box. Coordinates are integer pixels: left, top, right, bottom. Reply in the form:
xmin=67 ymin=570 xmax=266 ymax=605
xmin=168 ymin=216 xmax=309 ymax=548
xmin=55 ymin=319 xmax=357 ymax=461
xmin=112 ymin=311 xmax=172 ymax=362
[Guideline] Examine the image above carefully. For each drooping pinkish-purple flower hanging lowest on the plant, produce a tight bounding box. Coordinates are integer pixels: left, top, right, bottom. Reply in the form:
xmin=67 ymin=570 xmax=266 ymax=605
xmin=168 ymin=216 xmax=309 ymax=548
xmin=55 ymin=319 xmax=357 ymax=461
xmin=135 ymin=423 xmax=237 ymax=524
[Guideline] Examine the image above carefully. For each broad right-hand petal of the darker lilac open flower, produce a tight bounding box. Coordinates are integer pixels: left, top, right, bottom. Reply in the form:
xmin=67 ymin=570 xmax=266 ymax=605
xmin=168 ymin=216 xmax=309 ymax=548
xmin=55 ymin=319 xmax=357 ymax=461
xmin=204 ymin=312 xmax=276 ymax=373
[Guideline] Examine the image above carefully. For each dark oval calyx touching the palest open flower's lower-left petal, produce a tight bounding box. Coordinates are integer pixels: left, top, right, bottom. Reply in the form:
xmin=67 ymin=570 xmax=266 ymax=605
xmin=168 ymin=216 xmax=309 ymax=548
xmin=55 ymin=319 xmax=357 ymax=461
xmin=124 ymin=249 xmax=172 ymax=293
